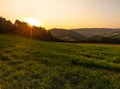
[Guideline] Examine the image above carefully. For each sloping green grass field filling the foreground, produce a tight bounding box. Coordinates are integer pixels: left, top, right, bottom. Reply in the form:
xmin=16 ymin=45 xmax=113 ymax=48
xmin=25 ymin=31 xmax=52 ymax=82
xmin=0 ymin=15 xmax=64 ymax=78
xmin=0 ymin=34 xmax=120 ymax=89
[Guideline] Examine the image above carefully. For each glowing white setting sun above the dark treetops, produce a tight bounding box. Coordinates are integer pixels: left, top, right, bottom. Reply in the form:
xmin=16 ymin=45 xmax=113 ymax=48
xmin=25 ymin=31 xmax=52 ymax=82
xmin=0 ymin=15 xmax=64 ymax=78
xmin=24 ymin=17 xmax=40 ymax=26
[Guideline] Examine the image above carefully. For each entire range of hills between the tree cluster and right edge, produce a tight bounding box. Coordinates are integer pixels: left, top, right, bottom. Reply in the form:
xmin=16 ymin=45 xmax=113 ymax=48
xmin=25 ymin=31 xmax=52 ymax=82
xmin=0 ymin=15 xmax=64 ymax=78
xmin=49 ymin=28 xmax=120 ymax=44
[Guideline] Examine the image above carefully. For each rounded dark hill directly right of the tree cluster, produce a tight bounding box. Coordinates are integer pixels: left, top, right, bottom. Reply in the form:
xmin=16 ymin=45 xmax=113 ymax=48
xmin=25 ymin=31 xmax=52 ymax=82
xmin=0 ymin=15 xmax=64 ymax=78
xmin=49 ymin=28 xmax=85 ymax=41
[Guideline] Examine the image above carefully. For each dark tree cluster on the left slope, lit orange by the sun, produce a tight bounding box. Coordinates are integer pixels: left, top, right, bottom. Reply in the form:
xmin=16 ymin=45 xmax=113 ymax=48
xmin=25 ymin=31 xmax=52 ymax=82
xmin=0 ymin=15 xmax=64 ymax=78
xmin=0 ymin=17 xmax=59 ymax=41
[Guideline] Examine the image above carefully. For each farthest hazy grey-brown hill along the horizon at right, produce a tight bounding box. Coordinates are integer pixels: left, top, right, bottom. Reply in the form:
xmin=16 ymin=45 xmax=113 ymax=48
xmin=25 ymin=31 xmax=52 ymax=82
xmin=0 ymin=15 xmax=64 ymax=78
xmin=71 ymin=28 xmax=120 ymax=38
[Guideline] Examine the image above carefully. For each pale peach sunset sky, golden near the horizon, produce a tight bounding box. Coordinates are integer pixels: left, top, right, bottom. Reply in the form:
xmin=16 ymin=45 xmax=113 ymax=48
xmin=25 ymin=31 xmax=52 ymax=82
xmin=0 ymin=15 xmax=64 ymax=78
xmin=0 ymin=0 xmax=120 ymax=29
